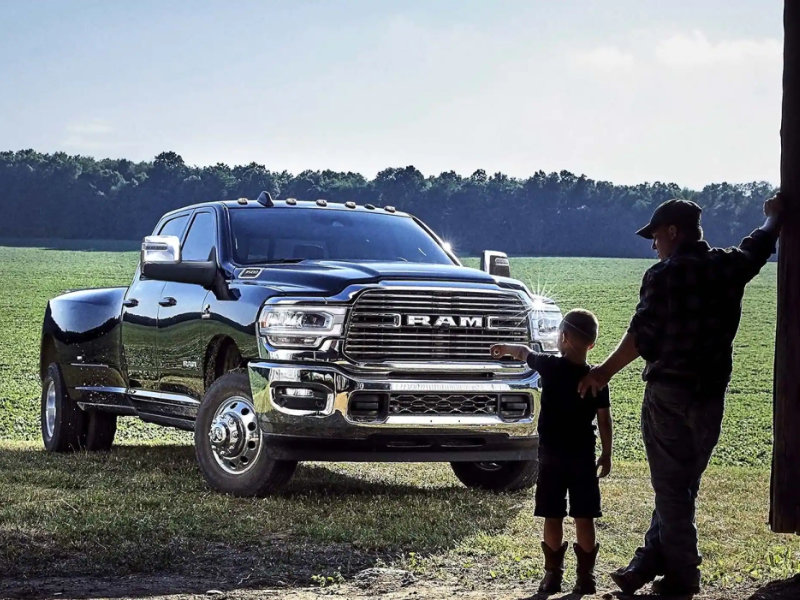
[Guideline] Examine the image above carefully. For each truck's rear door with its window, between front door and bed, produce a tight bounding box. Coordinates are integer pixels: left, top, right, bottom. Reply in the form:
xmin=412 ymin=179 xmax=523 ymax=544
xmin=122 ymin=213 xmax=189 ymax=391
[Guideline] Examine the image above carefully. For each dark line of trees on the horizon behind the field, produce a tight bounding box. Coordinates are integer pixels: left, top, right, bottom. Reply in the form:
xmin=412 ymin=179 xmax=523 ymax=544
xmin=0 ymin=150 xmax=775 ymax=257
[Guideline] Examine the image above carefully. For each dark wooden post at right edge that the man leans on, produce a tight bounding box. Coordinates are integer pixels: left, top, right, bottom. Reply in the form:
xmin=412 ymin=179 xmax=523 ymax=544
xmin=769 ymin=0 xmax=800 ymax=533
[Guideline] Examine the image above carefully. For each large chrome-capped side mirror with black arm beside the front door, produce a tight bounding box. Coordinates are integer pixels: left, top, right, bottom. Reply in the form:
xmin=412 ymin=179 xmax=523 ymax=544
xmin=141 ymin=235 xmax=217 ymax=289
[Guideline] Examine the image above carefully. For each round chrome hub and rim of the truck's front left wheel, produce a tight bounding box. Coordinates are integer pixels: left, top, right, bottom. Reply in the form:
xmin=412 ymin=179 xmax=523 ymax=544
xmin=208 ymin=396 xmax=261 ymax=475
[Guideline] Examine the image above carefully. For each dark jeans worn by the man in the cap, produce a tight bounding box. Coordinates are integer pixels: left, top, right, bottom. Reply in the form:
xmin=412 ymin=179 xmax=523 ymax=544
xmin=630 ymin=382 xmax=725 ymax=583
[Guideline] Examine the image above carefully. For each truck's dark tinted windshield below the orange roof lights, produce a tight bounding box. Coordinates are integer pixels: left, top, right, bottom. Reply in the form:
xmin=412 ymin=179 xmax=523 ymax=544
xmin=230 ymin=207 xmax=453 ymax=265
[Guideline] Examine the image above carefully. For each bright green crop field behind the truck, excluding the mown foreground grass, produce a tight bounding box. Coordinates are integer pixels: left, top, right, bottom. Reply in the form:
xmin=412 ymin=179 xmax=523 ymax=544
xmin=0 ymin=247 xmax=776 ymax=467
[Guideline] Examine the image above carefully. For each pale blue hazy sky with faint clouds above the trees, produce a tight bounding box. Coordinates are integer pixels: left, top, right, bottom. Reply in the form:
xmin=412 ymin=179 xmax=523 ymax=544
xmin=0 ymin=0 xmax=783 ymax=189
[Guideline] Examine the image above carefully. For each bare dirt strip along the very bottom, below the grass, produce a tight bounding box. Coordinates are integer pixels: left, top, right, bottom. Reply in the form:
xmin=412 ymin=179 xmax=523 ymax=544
xmin=0 ymin=568 xmax=800 ymax=600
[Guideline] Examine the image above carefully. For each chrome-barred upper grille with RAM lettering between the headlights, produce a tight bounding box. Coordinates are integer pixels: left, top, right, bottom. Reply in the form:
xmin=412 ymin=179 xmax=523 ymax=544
xmin=344 ymin=289 xmax=530 ymax=362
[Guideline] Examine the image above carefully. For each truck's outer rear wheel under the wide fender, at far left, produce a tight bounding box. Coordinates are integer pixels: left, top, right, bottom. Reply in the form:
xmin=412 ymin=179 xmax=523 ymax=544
xmin=40 ymin=363 xmax=86 ymax=452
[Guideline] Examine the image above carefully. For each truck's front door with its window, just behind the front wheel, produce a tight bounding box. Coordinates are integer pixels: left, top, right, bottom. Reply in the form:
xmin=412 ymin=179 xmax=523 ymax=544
xmin=158 ymin=210 xmax=219 ymax=400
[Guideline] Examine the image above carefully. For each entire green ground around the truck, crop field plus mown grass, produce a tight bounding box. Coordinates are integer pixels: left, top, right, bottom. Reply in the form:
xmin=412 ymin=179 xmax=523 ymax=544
xmin=0 ymin=247 xmax=800 ymax=598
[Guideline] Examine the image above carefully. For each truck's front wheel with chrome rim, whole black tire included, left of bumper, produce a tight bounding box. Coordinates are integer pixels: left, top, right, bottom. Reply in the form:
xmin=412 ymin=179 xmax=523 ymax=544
xmin=194 ymin=373 xmax=297 ymax=496
